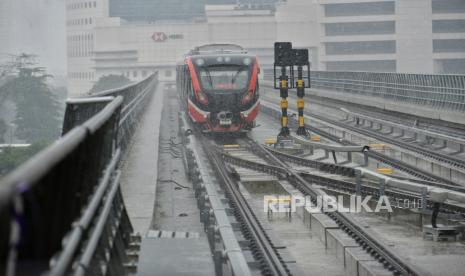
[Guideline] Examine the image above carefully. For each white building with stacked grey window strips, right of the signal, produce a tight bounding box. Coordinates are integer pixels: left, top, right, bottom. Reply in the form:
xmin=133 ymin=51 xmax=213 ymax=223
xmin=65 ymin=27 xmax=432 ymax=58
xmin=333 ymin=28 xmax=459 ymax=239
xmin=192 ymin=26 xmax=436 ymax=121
xmin=318 ymin=0 xmax=465 ymax=73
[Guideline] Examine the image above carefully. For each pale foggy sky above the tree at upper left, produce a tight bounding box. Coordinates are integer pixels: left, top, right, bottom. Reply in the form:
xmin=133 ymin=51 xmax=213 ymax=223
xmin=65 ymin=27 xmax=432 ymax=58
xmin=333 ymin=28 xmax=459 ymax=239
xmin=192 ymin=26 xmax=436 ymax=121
xmin=0 ymin=0 xmax=66 ymax=75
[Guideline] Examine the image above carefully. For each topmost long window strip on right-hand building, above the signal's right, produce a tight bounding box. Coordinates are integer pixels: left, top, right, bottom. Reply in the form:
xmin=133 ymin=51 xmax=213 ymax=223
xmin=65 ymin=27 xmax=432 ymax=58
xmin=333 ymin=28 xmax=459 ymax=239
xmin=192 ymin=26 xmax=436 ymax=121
xmin=324 ymin=1 xmax=395 ymax=17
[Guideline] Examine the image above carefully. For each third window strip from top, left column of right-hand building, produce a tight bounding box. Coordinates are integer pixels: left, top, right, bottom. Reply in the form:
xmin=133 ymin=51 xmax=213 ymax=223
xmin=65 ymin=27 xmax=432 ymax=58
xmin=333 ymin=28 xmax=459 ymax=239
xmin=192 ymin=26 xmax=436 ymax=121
xmin=325 ymin=40 xmax=396 ymax=55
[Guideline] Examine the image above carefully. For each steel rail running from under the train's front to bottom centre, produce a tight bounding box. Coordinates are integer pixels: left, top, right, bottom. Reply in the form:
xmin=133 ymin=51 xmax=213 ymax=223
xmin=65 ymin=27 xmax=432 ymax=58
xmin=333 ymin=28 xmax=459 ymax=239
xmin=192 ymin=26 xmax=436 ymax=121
xmin=203 ymin=142 xmax=292 ymax=275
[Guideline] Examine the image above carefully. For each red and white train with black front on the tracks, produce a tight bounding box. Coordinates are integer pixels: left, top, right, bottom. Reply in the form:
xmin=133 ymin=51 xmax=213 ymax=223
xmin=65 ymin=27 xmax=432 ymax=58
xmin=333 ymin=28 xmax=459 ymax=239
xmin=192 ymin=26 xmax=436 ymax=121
xmin=176 ymin=44 xmax=260 ymax=133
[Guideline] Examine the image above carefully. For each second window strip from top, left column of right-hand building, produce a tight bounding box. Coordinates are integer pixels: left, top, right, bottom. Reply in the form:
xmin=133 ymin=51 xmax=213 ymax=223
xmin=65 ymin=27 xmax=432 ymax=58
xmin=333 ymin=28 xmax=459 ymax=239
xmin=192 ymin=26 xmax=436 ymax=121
xmin=325 ymin=21 xmax=396 ymax=36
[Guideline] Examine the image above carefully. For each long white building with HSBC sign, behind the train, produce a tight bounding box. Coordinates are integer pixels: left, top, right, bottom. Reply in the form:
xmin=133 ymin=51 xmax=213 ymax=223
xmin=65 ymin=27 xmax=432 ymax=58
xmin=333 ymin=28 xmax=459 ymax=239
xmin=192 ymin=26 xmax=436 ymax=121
xmin=67 ymin=0 xmax=318 ymax=95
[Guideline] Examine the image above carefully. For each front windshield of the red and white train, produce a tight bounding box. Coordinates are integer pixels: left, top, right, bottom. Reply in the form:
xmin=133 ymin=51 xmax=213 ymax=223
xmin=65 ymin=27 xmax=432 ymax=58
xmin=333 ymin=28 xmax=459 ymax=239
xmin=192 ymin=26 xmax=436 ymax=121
xmin=198 ymin=65 xmax=250 ymax=92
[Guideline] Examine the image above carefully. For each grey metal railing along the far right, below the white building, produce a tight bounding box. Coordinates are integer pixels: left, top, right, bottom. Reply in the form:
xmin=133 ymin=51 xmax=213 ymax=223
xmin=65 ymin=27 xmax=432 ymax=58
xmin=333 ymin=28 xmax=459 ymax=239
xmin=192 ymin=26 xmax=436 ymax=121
xmin=265 ymin=71 xmax=465 ymax=112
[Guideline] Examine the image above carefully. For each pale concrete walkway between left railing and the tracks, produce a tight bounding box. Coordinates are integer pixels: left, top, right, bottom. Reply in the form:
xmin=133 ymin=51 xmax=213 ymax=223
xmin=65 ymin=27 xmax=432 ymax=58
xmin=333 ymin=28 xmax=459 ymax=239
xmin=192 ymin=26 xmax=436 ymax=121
xmin=132 ymin=83 xmax=215 ymax=276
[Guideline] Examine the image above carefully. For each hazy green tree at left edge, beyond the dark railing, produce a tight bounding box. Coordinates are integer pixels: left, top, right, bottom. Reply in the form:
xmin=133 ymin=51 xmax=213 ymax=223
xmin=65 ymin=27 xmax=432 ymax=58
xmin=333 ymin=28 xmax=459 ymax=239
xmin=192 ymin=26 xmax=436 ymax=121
xmin=0 ymin=54 xmax=63 ymax=143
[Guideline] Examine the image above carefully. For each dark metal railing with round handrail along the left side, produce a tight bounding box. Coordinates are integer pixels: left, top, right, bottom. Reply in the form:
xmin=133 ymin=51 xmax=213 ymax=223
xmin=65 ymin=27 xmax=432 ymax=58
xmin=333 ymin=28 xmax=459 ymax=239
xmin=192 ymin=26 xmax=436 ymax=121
xmin=0 ymin=74 xmax=158 ymax=275
